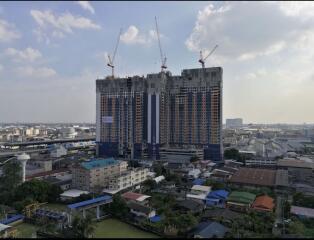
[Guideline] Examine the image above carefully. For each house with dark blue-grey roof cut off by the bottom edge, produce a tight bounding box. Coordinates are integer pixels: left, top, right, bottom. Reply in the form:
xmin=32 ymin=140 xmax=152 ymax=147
xmin=193 ymin=222 xmax=229 ymax=238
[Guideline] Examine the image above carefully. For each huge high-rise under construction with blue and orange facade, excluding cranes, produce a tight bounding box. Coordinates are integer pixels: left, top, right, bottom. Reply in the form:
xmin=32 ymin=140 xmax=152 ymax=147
xmin=96 ymin=67 xmax=223 ymax=161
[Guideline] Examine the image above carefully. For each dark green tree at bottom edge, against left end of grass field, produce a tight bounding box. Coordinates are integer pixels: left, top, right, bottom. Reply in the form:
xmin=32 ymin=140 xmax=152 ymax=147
xmin=72 ymin=215 xmax=95 ymax=238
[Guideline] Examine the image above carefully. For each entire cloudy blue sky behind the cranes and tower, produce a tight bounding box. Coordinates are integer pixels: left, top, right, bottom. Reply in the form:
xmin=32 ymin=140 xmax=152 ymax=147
xmin=0 ymin=2 xmax=314 ymax=123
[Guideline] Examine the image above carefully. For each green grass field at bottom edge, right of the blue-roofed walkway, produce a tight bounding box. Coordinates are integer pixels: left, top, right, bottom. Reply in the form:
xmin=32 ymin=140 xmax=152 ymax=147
xmin=94 ymin=219 xmax=158 ymax=238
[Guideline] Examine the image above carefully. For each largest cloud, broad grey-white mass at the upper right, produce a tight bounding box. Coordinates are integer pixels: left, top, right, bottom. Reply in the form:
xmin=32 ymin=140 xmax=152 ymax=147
xmin=185 ymin=2 xmax=314 ymax=60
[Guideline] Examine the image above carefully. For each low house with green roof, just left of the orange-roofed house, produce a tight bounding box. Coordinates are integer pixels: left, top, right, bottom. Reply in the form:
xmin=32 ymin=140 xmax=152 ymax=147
xmin=226 ymin=191 xmax=256 ymax=212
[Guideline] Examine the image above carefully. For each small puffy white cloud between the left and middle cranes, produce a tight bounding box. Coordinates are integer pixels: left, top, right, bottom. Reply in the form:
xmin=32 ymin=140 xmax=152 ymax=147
xmin=120 ymin=25 xmax=164 ymax=45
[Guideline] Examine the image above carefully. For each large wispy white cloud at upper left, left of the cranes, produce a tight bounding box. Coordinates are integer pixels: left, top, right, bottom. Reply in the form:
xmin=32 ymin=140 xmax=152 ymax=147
xmin=30 ymin=10 xmax=101 ymax=43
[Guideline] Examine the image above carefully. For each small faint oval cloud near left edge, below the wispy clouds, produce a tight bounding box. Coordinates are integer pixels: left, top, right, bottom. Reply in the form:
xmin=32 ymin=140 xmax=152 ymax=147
xmin=5 ymin=47 xmax=42 ymax=62
